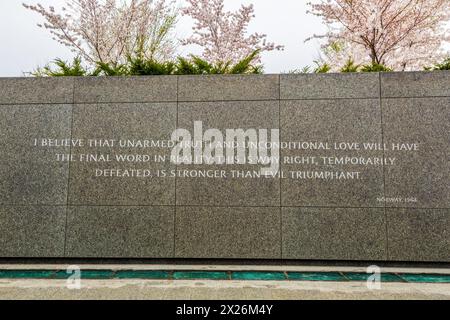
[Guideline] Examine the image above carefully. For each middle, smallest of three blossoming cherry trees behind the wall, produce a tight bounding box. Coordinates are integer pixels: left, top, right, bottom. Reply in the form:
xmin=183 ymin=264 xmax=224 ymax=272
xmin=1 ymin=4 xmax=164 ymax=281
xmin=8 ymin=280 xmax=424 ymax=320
xmin=182 ymin=0 xmax=283 ymax=63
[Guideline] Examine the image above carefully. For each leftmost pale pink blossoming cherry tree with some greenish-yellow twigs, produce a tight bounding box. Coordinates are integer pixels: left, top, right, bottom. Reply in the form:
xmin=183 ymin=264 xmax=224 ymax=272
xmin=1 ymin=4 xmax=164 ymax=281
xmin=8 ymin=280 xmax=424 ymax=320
xmin=23 ymin=0 xmax=176 ymax=65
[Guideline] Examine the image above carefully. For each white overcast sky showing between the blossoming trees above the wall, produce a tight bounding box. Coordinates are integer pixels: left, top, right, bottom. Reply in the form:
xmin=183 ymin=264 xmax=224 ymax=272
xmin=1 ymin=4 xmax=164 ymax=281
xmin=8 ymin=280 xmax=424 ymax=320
xmin=0 ymin=0 xmax=324 ymax=76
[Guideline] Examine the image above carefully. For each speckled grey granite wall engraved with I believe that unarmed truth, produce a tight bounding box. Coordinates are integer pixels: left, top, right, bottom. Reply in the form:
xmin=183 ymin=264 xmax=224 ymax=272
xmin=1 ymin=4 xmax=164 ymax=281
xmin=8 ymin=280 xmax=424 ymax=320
xmin=0 ymin=71 xmax=450 ymax=262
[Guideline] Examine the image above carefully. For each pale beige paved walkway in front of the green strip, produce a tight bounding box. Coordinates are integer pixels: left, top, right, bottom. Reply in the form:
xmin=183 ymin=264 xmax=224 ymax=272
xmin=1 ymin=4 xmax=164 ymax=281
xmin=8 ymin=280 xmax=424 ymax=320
xmin=0 ymin=279 xmax=450 ymax=300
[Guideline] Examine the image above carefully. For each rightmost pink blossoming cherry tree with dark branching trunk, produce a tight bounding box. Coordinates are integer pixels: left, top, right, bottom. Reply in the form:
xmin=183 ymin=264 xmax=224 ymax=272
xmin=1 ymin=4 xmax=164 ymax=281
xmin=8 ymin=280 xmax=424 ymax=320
xmin=307 ymin=0 xmax=450 ymax=70
